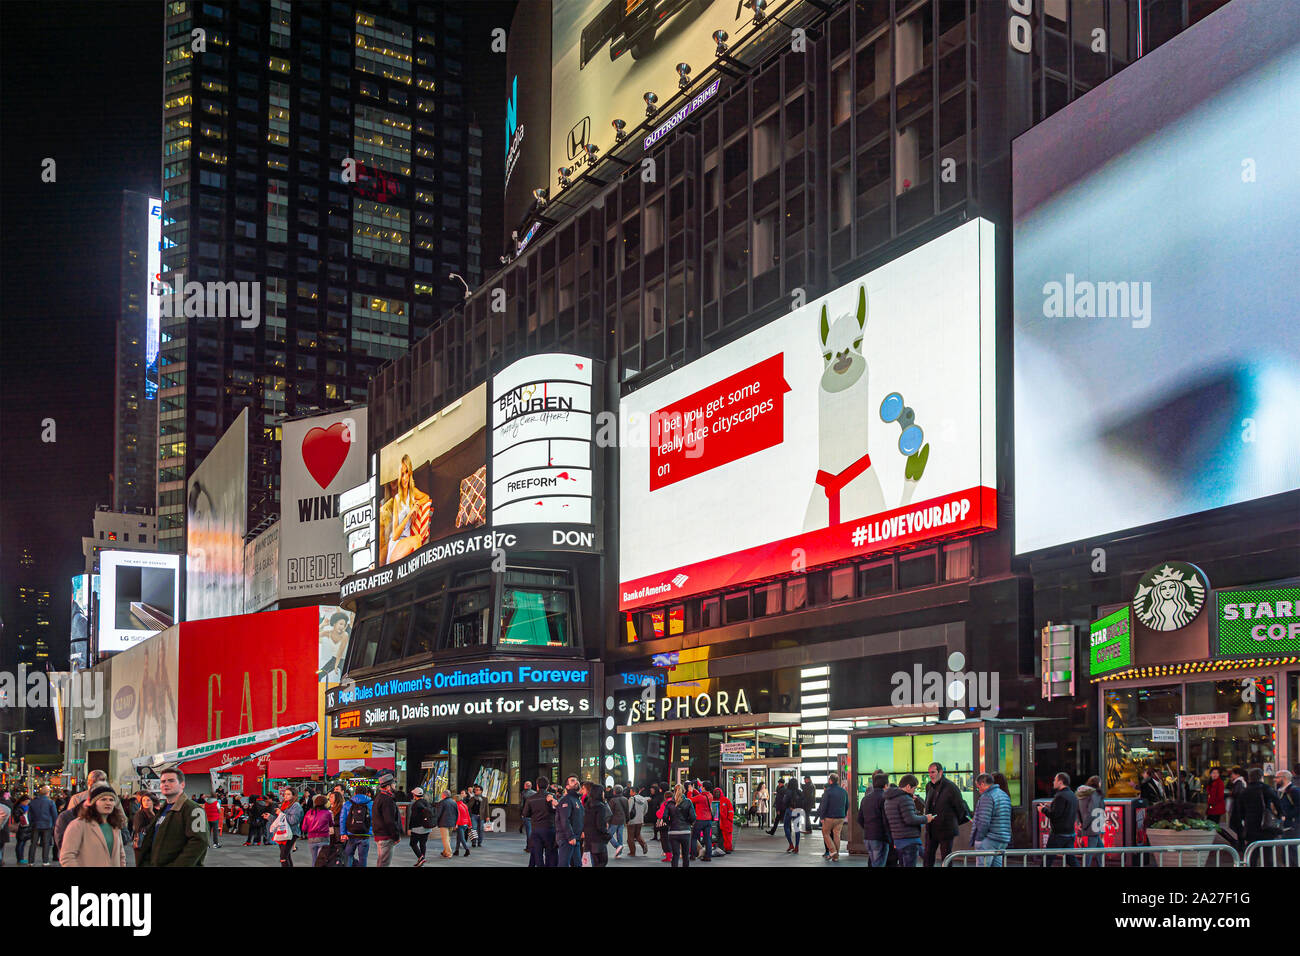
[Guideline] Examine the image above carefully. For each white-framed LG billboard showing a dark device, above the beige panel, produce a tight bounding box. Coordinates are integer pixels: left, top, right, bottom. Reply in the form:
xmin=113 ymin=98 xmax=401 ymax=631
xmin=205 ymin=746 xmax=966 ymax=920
xmin=99 ymin=551 xmax=181 ymax=653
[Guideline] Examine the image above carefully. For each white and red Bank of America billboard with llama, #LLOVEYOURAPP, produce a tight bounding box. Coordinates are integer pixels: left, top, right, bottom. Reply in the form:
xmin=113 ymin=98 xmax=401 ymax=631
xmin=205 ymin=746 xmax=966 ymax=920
xmin=619 ymin=220 xmax=997 ymax=610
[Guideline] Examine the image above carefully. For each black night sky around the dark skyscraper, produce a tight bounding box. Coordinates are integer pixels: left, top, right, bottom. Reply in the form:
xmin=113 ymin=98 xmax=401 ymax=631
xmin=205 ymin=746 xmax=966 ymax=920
xmin=0 ymin=0 xmax=515 ymax=663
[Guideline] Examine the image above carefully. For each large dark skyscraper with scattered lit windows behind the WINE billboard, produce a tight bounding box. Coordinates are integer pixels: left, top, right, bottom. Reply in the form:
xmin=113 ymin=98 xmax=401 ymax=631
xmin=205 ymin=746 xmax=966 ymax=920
xmin=157 ymin=0 xmax=481 ymax=551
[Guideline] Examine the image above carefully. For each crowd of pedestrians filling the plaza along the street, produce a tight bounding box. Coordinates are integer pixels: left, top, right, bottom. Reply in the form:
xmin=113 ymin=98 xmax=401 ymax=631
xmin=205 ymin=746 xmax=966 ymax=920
xmin=0 ymin=762 xmax=1300 ymax=868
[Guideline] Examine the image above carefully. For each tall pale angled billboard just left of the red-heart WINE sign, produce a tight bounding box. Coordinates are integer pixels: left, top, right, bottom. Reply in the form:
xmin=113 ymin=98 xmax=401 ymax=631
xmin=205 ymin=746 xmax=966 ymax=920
xmin=185 ymin=408 xmax=248 ymax=620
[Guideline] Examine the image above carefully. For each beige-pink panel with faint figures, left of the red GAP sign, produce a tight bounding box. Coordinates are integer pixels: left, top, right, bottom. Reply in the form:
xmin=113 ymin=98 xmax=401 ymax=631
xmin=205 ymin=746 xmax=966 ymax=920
xmin=109 ymin=624 xmax=181 ymax=786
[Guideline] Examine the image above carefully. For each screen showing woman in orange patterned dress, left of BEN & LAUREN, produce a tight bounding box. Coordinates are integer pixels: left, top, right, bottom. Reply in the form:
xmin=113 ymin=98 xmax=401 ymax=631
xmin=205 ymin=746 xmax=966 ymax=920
xmin=377 ymin=382 xmax=488 ymax=567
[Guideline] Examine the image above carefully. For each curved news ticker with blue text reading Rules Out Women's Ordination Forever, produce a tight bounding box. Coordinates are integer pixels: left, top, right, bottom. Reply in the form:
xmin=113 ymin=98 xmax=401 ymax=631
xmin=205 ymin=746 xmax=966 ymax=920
xmin=325 ymin=661 xmax=593 ymax=709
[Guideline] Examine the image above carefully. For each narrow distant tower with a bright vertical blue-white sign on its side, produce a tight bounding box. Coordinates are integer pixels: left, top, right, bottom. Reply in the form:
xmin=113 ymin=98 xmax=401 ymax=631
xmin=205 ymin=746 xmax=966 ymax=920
xmin=113 ymin=190 xmax=163 ymax=511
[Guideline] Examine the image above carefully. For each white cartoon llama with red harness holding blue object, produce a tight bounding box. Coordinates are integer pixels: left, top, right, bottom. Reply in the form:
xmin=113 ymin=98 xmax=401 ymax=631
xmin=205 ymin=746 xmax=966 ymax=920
xmin=803 ymin=286 xmax=930 ymax=531
